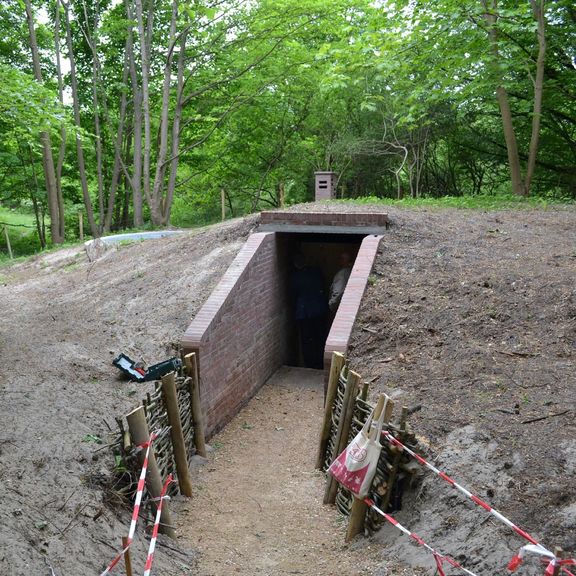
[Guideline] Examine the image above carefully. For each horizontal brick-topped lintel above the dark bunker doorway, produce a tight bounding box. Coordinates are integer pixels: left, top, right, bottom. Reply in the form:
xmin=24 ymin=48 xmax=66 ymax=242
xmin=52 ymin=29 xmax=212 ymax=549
xmin=260 ymin=210 xmax=389 ymax=228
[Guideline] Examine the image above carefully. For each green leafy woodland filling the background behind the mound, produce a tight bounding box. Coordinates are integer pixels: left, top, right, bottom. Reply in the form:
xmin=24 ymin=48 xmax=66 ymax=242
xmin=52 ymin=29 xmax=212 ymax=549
xmin=0 ymin=0 xmax=576 ymax=243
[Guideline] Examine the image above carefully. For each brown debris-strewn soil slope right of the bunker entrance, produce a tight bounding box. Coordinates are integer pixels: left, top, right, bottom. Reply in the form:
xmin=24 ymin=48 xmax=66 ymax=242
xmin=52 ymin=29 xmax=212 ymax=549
xmin=352 ymin=209 xmax=576 ymax=574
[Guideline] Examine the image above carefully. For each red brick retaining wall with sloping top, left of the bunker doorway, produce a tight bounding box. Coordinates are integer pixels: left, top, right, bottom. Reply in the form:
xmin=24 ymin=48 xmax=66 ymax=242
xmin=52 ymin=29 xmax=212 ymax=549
xmin=182 ymin=233 xmax=289 ymax=434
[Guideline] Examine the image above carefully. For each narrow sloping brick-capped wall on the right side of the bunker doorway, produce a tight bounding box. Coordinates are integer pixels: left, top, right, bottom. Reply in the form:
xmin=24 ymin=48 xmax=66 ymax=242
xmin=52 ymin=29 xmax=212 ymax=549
xmin=324 ymin=236 xmax=382 ymax=370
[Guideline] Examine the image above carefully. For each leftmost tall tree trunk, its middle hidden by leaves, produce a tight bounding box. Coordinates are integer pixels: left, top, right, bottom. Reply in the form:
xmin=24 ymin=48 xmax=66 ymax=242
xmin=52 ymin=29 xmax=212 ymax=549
xmin=24 ymin=0 xmax=64 ymax=244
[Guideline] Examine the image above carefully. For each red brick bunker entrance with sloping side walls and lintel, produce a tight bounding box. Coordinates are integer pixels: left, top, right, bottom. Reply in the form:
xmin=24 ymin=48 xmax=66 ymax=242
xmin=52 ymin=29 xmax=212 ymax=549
xmin=182 ymin=211 xmax=388 ymax=436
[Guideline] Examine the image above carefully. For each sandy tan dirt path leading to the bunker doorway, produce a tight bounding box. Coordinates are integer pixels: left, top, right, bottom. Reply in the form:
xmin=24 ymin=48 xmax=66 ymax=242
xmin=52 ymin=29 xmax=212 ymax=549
xmin=175 ymin=368 xmax=388 ymax=576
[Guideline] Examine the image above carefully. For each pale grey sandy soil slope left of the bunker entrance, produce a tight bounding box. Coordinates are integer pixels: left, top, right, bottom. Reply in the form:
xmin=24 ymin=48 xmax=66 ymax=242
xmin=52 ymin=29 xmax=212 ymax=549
xmin=0 ymin=218 xmax=255 ymax=576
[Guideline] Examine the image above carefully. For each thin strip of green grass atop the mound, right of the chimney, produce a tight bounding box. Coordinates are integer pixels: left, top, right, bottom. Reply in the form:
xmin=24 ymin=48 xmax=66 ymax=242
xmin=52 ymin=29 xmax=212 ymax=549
xmin=332 ymin=194 xmax=575 ymax=210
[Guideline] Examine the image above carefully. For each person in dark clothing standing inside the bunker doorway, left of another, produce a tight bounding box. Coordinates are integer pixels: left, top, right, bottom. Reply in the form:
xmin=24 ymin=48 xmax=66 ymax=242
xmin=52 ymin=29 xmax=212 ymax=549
xmin=290 ymin=254 xmax=328 ymax=369
